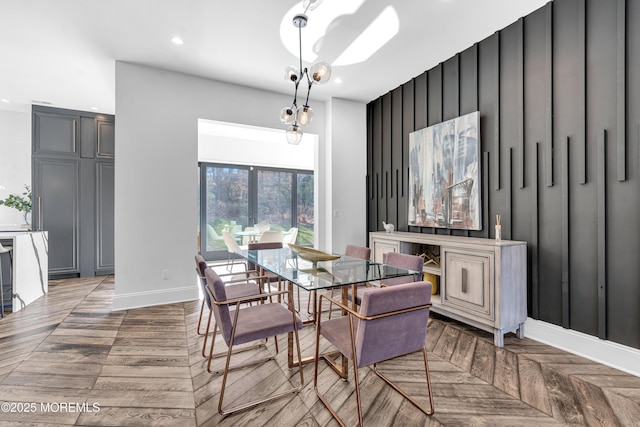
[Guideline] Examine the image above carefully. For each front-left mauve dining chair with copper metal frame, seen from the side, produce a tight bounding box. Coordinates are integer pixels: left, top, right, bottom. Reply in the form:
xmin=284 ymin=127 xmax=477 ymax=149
xmin=205 ymin=268 xmax=304 ymax=415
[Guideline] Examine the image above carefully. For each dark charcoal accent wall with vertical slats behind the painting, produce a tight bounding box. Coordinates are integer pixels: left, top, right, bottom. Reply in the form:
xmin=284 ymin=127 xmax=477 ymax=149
xmin=367 ymin=0 xmax=640 ymax=348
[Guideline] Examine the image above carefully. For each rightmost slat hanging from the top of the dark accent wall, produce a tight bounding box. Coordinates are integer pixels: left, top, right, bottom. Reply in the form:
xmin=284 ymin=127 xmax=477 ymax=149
xmin=616 ymin=0 xmax=627 ymax=181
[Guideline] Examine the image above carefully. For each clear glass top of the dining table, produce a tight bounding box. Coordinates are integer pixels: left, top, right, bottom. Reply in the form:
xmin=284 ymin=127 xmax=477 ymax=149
xmin=237 ymin=248 xmax=422 ymax=290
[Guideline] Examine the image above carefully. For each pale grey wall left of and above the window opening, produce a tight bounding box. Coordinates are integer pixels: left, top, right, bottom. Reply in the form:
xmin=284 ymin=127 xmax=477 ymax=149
xmin=113 ymin=62 xmax=348 ymax=309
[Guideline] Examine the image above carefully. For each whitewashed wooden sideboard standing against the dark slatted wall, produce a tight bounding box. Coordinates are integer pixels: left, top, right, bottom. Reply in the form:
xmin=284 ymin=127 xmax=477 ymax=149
xmin=369 ymin=231 xmax=527 ymax=347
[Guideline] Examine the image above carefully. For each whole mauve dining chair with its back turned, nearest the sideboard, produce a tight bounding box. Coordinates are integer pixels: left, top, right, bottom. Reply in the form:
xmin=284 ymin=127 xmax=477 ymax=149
xmin=313 ymin=282 xmax=433 ymax=426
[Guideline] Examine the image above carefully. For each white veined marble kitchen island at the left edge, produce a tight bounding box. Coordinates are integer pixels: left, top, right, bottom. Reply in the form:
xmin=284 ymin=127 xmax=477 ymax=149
xmin=0 ymin=231 xmax=49 ymax=313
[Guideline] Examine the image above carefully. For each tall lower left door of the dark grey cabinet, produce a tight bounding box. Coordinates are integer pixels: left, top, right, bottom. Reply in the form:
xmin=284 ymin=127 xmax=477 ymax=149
xmin=33 ymin=158 xmax=79 ymax=276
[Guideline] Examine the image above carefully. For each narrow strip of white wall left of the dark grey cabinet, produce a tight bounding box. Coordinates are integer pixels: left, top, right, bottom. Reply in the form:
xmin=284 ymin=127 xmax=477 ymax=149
xmin=0 ymin=109 xmax=31 ymax=229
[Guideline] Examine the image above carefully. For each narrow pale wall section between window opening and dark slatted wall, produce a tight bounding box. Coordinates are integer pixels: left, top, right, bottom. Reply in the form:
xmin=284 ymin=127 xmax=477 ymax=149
xmin=325 ymin=98 xmax=369 ymax=253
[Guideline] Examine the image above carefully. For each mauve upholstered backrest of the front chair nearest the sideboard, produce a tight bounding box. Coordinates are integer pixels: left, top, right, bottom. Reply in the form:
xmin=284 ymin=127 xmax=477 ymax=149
xmin=355 ymin=282 xmax=431 ymax=367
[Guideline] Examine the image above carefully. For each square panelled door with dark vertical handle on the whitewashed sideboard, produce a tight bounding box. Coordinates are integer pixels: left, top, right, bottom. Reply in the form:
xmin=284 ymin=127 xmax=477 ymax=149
xmin=442 ymin=250 xmax=494 ymax=319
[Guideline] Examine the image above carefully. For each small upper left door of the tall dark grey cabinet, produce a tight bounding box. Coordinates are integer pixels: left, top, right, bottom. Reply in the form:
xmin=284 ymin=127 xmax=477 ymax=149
xmin=33 ymin=112 xmax=79 ymax=157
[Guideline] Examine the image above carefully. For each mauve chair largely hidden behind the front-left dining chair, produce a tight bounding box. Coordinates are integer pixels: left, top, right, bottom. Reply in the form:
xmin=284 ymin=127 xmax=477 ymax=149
xmin=195 ymin=254 xmax=262 ymax=357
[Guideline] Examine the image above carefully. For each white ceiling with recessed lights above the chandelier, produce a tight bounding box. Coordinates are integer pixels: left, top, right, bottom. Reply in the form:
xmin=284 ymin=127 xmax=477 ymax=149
xmin=0 ymin=0 xmax=548 ymax=114
